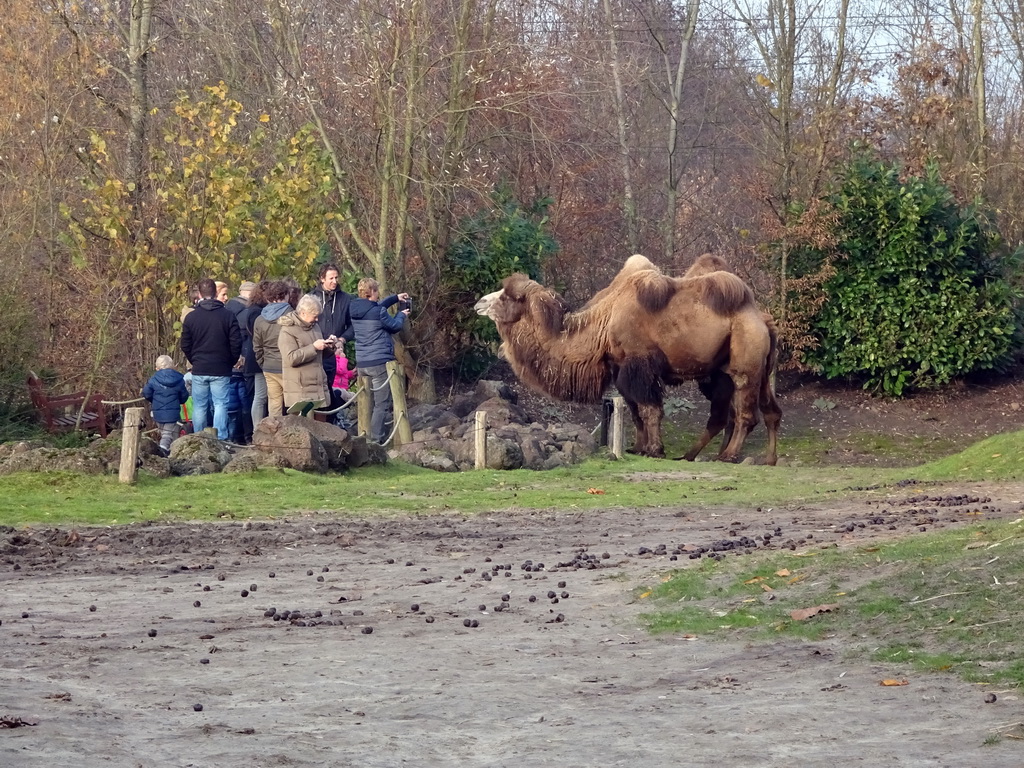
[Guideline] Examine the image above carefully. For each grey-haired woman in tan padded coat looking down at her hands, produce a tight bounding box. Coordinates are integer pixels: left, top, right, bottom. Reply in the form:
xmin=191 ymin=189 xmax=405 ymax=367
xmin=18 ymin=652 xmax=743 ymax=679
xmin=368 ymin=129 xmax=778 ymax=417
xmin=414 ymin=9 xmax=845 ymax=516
xmin=278 ymin=294 xmax=334 ymax=416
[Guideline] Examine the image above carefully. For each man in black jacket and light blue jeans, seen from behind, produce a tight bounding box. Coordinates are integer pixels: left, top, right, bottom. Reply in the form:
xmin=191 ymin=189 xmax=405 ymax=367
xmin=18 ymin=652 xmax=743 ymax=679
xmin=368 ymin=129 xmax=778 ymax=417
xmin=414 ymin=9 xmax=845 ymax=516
xmin=181 ymin=278 xmax=242 ymax=440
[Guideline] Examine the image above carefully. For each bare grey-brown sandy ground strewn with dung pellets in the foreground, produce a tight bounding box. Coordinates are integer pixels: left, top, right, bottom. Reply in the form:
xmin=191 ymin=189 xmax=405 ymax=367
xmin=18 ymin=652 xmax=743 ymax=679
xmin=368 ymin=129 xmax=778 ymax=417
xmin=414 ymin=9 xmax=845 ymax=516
xmin=0 ymin=478 xmax=1024 ymax=768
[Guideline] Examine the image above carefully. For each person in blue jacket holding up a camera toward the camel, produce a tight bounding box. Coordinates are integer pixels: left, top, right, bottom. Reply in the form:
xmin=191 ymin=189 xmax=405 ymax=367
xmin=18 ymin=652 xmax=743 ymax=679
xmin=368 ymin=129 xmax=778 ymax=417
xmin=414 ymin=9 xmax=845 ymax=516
xmin=348 ymin=278 xmax=410 ymax=444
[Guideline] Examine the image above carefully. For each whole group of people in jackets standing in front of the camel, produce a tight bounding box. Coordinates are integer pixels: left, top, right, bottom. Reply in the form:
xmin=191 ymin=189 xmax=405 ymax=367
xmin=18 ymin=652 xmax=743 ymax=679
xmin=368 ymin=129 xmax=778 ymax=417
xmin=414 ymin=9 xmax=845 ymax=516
xmin=142 ymin=264 xmax=410 ymax=454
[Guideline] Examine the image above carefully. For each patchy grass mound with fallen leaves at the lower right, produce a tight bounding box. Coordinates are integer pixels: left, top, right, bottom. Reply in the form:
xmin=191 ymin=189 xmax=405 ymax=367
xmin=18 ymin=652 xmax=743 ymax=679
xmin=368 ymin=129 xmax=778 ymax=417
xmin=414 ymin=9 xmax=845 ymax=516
xmin=641 ymin=520 xmax=1024 ymax=686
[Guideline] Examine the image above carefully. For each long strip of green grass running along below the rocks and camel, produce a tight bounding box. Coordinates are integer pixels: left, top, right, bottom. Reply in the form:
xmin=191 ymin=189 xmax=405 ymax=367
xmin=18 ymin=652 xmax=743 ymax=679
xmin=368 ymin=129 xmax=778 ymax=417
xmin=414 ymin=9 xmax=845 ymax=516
xmin=0 ymin=431 xmax=1024 ymax=525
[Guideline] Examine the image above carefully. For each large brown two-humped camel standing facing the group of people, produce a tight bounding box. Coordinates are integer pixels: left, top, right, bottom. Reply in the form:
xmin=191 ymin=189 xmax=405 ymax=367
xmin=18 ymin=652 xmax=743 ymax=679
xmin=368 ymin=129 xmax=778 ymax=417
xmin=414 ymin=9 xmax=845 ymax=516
xmin=476 ymin=256 xmax=771 ymax=461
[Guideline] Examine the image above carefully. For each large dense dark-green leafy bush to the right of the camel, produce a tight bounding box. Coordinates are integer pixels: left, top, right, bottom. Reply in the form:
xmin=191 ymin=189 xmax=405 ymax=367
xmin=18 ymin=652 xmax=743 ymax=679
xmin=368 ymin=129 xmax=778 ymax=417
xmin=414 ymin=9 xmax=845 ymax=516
xmin=797 ymin=153 xmax=1020 ymax=396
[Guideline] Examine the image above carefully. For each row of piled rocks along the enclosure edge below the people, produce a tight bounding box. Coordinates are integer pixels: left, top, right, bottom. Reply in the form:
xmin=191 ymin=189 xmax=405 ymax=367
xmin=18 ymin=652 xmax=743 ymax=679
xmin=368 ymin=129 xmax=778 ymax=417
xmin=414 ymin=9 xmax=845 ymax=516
xmin=0 ymin=381 xmax=597 ymax=477
